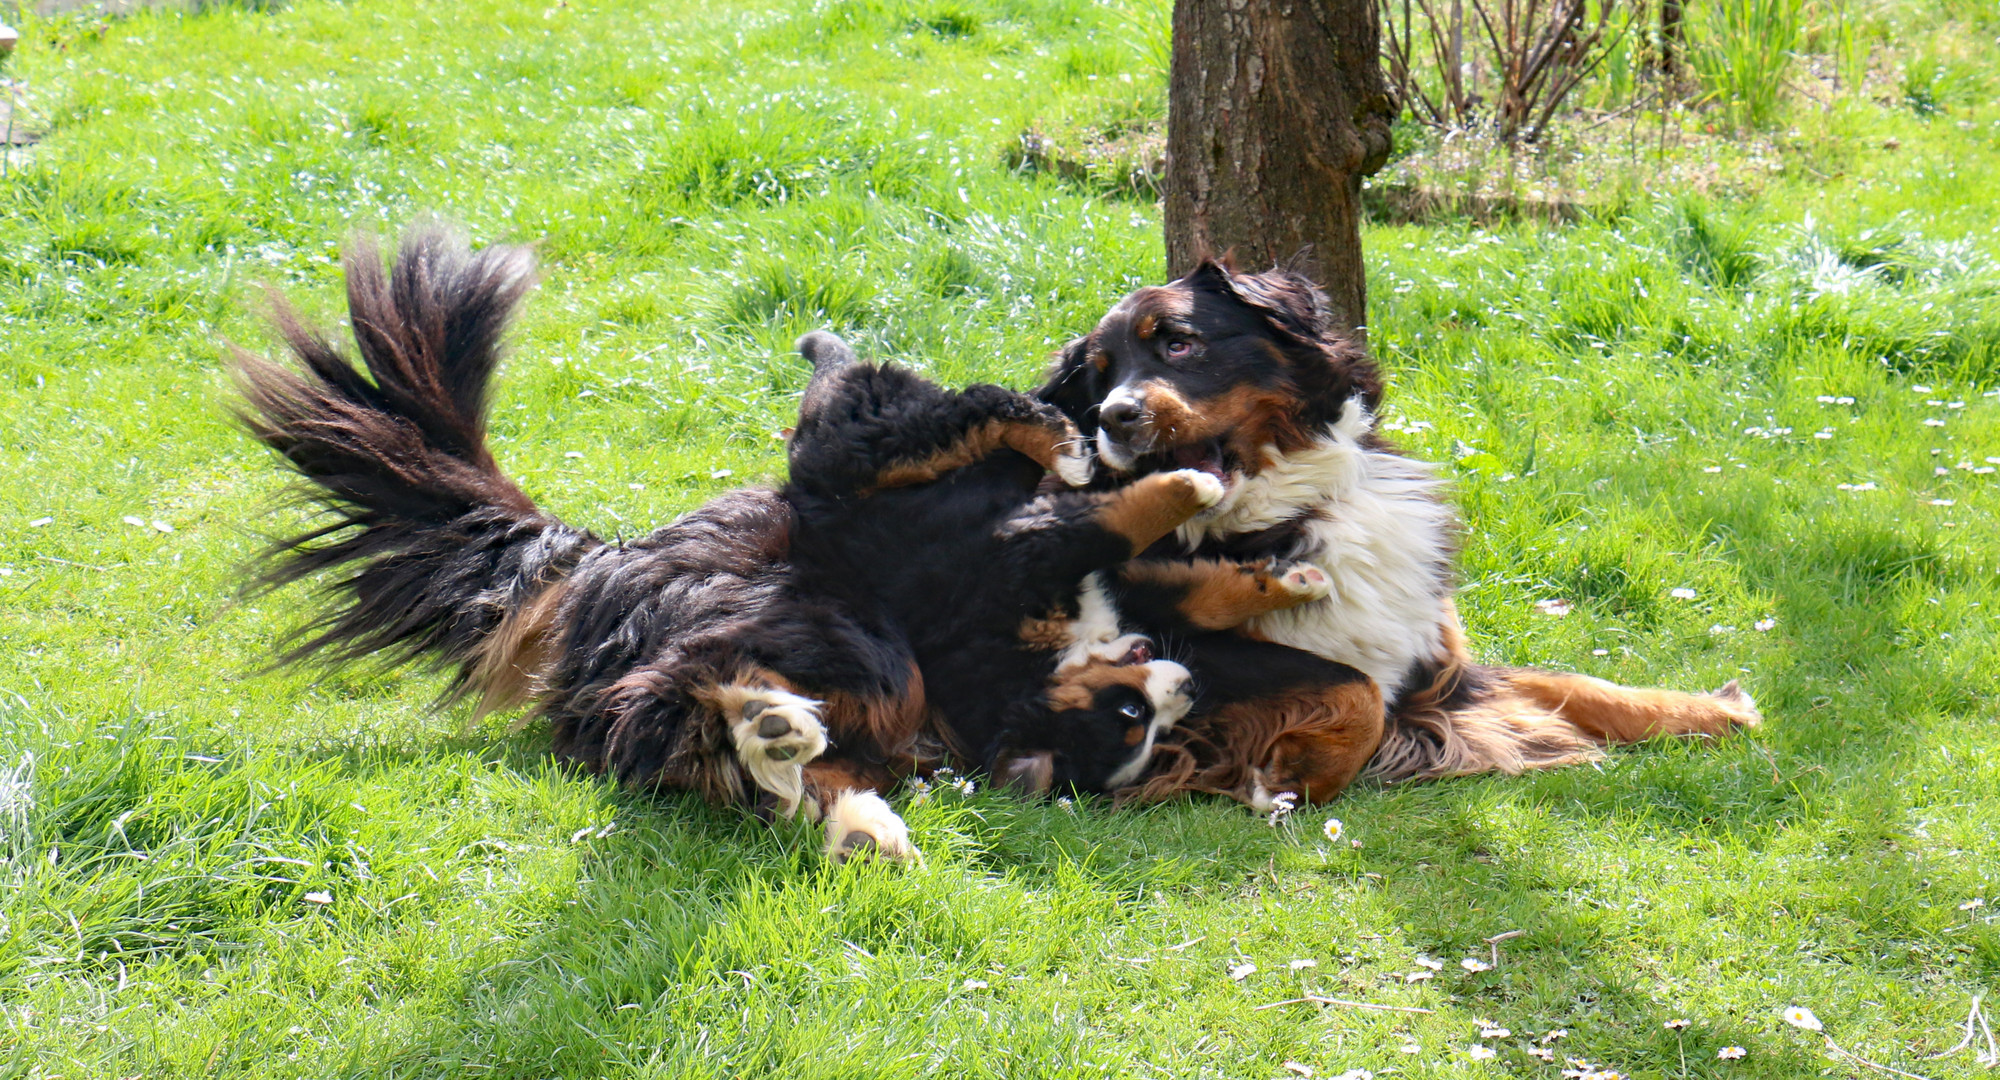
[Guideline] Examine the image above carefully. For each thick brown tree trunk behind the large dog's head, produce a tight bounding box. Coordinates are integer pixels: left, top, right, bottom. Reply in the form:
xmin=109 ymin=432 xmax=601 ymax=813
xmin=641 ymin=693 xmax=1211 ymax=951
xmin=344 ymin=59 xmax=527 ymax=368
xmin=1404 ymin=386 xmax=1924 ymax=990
xmin=1166 ymin=0 xmax=1396 ymax=338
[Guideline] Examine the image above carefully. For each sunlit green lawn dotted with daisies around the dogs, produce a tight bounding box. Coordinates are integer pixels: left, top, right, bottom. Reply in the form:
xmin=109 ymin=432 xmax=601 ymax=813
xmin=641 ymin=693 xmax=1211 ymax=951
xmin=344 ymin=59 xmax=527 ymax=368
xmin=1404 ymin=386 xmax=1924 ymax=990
xmin=0 ymin=0 xmax=2000 ymax=1080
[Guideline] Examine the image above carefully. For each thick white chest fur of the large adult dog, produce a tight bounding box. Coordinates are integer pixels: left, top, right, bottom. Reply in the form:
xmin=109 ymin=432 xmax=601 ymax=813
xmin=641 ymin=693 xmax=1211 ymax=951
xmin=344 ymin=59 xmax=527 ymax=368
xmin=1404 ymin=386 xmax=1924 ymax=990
xmin=1180 ymin=400 xmax=1456 ymax=702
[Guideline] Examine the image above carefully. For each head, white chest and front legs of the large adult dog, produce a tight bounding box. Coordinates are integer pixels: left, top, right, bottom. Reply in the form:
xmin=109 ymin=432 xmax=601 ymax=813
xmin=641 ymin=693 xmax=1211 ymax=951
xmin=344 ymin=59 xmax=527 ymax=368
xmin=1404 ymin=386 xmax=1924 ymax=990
xmin=1036 ymin=260 xmax=1760 ymax=808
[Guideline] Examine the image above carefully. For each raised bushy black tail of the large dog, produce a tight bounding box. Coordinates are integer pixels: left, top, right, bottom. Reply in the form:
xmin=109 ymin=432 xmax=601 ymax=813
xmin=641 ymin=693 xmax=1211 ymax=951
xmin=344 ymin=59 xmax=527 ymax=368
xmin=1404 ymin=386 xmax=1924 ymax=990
xmin=234 ymin=226 xmax=598 ymax=692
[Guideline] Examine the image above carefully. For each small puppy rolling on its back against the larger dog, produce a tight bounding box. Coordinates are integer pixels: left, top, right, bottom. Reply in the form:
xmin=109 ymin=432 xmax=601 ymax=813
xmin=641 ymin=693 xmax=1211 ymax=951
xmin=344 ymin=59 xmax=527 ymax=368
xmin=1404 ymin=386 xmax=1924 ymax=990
xmin=788 ymin=332 xmax=1362 ymax=804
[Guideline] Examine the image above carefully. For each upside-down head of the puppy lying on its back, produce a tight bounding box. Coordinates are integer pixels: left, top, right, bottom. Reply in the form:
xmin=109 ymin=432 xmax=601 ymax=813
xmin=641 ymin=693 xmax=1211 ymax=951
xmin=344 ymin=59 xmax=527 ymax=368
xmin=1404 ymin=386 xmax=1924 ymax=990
xmin=990 ymin=650 xmax=1194 ymax=794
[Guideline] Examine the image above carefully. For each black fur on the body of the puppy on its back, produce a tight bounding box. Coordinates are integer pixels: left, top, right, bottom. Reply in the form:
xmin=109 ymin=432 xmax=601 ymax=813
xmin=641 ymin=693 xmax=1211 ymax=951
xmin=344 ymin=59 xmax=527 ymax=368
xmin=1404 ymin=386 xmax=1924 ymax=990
xmin=790 ymin=354 xmax=1184 ymax=790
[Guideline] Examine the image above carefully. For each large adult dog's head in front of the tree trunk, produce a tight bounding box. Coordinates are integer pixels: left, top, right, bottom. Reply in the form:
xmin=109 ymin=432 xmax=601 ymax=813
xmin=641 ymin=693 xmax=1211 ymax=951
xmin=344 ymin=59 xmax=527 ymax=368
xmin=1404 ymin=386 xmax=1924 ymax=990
xmin=1036 ymin=260 xmax=1382 ymax=482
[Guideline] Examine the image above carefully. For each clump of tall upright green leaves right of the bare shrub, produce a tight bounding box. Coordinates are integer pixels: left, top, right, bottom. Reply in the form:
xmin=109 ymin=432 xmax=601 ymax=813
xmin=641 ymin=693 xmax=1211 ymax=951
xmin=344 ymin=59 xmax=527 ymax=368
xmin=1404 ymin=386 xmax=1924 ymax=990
xmin=1688 ymin=0 xmax=1806 ymax=128
